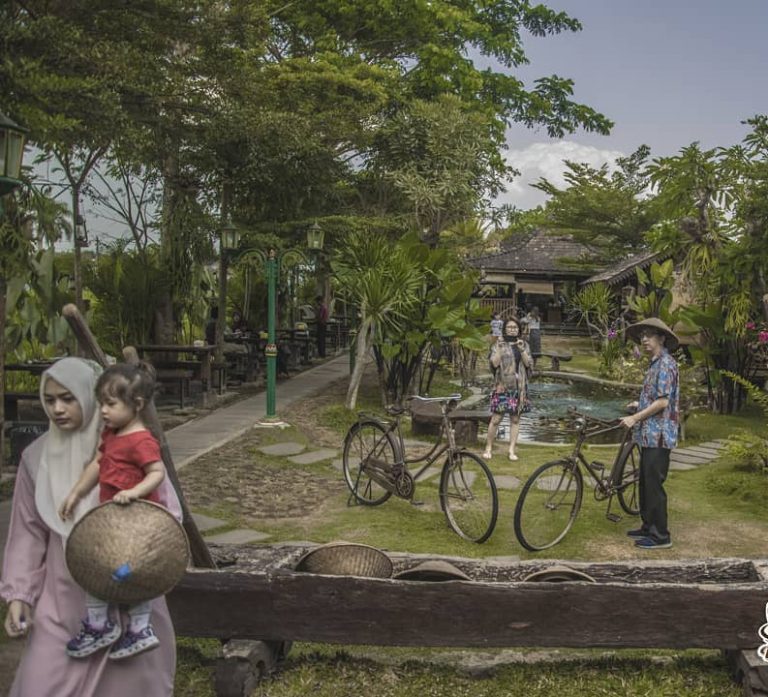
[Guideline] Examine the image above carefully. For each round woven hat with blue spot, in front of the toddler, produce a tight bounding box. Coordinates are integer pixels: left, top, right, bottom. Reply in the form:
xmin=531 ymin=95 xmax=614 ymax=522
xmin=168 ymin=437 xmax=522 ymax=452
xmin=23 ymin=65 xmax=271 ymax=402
xmin=66 ymin=501 xmax=189 ymax=605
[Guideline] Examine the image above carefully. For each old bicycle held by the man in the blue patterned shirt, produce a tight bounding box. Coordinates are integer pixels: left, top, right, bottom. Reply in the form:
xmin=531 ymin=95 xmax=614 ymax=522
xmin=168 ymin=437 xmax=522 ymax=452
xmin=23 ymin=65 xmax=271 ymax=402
xmin=515 ymin=412 xmax=640 ymax=552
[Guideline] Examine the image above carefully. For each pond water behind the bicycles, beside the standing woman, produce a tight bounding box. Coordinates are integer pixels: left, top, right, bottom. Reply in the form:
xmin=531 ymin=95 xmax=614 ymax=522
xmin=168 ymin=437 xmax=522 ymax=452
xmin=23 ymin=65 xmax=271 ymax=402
xmin=475 ymin=380 xmax=637 ymax=443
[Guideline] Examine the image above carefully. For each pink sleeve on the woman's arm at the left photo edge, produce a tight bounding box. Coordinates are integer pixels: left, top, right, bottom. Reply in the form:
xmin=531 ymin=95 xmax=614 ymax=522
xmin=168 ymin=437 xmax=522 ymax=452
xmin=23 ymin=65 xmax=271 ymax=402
xmin=0 ymin=461 xmax=49 ymax=605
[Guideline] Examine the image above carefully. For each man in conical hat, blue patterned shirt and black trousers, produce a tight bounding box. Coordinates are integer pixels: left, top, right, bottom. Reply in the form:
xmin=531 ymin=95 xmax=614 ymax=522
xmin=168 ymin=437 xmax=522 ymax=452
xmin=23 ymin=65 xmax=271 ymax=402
xmin=622 ymin=317 xmax=680 ymax=549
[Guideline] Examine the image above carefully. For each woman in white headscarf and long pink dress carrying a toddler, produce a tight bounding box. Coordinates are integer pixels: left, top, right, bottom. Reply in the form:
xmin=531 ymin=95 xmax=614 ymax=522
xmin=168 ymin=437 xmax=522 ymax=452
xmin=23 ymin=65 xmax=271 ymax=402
xmin=0 ymin=358 xmax=180 ymax=697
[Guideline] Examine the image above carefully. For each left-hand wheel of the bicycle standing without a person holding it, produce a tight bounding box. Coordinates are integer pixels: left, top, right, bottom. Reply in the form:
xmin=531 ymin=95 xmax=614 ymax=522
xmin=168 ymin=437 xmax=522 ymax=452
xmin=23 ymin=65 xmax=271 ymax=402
xmin=342 ymin=421 xmax=398 ymax=506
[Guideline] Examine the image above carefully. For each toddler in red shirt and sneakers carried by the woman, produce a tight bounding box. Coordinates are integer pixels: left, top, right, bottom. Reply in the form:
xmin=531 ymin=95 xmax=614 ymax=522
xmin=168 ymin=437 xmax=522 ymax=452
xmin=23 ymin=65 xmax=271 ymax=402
xmin=59 ymin=363 xmax=166 ymax=660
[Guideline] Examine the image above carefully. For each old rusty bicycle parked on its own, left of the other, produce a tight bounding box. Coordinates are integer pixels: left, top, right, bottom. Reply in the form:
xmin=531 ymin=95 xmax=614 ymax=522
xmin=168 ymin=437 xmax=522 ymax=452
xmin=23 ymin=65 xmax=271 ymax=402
xmin=343 ymin=394 xmax=499 ymax=542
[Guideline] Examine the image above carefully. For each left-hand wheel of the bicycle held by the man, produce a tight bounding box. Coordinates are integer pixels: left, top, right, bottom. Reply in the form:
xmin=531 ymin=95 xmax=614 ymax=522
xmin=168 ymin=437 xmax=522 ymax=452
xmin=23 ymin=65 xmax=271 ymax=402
xmin=515 ymin=460 xmax=584 ymax=552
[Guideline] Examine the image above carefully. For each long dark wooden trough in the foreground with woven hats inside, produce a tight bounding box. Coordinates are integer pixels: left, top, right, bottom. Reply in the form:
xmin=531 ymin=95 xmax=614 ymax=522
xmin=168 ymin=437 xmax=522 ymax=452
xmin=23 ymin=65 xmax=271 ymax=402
xmin=168 ymin=543 xmax=768 ymax=697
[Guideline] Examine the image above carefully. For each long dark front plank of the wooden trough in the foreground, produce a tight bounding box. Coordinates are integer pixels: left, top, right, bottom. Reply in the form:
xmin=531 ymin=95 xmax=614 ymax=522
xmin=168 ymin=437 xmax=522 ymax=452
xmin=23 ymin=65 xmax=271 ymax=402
xmin=168 ymin=570 xmax=768 ymax=649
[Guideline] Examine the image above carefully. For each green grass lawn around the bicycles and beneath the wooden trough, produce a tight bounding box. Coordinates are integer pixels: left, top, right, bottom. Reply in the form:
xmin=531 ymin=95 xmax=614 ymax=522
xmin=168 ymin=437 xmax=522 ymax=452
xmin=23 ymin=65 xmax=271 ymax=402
xmin=171 ymin=340 xmax=768 ymax=697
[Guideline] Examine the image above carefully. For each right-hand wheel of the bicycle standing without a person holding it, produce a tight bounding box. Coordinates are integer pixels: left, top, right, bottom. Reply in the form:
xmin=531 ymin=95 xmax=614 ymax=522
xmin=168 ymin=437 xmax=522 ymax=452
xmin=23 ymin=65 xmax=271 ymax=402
xmin=440 ymin=451 xmax=499 ymax=542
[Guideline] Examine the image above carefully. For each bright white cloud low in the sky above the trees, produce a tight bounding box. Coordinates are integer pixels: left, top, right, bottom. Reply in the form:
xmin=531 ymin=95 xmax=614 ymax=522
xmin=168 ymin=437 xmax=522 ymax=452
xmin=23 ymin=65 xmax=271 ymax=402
xmin=496 ymin=140 xmax=625 ymax=210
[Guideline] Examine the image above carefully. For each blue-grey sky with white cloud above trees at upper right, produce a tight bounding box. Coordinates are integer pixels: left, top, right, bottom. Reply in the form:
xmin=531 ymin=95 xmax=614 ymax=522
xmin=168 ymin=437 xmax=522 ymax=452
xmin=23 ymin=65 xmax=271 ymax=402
xmin=498 ymin=0 xmax=768 ymax=209
